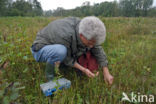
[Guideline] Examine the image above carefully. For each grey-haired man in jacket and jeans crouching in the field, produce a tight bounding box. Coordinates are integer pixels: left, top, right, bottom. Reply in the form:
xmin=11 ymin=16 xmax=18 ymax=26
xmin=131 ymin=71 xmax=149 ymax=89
xmin=31 ymin=16 xmax=113 ymax=85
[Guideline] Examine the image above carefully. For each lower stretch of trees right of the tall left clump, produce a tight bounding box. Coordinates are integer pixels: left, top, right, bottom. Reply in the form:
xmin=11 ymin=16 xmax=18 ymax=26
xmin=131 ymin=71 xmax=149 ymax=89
xmin=50 ymin=0 xmax=156 ymax=17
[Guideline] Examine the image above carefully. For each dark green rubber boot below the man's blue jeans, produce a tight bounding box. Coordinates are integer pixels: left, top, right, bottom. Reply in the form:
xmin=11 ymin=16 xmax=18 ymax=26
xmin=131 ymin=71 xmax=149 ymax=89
xmin=45 ymin=63 xmax=55 ymax=81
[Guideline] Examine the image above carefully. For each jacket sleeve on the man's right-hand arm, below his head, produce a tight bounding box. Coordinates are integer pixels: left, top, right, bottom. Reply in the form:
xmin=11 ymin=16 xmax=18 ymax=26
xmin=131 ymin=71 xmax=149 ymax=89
xmin=91 ymin=45 xmax=108 ymax=67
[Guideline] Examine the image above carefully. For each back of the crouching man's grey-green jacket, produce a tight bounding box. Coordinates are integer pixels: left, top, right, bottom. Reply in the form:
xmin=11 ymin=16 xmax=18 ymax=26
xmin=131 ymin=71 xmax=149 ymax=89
xmin=33 ymin=17 xmax=80 ymax=51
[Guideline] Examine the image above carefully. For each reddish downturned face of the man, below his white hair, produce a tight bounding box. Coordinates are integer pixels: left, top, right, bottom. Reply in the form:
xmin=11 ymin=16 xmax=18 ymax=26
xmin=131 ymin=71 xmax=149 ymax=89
xmin=80 ymin=34 xmax=96 ymax=48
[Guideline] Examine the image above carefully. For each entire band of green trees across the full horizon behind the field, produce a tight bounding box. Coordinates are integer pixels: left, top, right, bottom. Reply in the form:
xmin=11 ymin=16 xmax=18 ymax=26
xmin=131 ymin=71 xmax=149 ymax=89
xmin=0 ymin=0 xmax=156 ymax=17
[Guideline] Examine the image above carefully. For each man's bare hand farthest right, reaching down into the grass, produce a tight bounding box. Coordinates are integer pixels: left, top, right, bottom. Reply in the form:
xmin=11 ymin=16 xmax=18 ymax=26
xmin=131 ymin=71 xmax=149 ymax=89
xmin=103 ymin=67 xmax=114 ymax=85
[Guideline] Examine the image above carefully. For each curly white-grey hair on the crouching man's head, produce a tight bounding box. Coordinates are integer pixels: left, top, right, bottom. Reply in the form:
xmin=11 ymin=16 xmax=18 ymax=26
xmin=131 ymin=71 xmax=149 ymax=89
xmin=79 ymin=16 xmax=106 ymax=45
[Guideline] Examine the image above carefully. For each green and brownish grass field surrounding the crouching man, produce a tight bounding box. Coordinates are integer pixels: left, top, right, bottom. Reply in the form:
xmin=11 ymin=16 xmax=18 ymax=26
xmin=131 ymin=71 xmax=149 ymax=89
xmin=0 ymin=17 xmax=156 ymax=104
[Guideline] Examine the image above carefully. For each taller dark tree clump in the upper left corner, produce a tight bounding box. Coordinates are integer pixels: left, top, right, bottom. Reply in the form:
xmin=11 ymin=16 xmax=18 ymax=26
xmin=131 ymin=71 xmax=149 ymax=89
xmin=0 ymin=0 xmax=43 ymax=16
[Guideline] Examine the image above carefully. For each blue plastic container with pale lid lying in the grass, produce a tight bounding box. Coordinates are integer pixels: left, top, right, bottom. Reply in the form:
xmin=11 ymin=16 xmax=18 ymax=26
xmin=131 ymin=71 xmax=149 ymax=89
xmin=40 ymin=78 xmax=71 ymax=96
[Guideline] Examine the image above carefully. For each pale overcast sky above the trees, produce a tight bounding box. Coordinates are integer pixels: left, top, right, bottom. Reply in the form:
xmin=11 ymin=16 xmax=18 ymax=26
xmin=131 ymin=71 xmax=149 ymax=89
xmin=38 ymin=0 xmax=156 ymax=10
